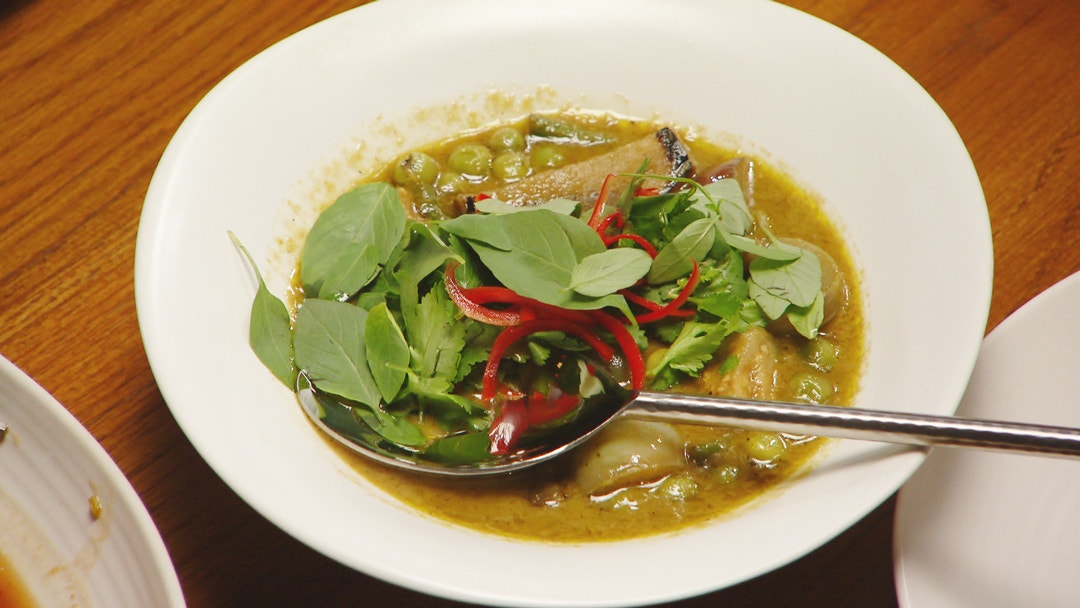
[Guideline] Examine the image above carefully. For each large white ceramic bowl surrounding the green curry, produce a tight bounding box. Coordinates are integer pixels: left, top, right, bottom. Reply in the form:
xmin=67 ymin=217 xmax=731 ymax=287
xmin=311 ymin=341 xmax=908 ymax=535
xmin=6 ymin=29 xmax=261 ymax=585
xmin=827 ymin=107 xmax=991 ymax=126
xmin=135 ymin=0 xmax=993 ymax=606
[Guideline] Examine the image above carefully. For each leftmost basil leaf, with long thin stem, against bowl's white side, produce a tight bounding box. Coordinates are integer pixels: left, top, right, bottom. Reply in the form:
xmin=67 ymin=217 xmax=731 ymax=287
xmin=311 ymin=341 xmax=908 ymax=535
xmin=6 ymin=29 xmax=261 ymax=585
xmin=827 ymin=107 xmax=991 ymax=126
xmin=229 ymin=232 xmax=296 ymax=389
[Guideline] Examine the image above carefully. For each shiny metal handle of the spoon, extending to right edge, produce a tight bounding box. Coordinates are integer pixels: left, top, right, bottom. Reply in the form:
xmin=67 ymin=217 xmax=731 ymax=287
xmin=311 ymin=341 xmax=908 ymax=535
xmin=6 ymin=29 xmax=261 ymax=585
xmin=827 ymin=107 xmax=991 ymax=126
xmin=623 ymin=392 xmax=1080 ymax=457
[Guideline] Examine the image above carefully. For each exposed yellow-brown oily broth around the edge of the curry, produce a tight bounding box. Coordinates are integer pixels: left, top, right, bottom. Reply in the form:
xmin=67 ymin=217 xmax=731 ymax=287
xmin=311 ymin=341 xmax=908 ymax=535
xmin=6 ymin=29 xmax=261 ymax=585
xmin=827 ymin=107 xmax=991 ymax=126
xmin=304 ymin=114 xmax=864 ymax=542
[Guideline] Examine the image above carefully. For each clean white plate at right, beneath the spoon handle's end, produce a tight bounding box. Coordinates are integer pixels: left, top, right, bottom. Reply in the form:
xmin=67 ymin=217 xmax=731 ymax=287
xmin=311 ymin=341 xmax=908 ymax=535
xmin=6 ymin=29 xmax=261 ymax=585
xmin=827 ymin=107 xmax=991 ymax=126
xmin=895 ymin=273 xmax=1080 ymax=608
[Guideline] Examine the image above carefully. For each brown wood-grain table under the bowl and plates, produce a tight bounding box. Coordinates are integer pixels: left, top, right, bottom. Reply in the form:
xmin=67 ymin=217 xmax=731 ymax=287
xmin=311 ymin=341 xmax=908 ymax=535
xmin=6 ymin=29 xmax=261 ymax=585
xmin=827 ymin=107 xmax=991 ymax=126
xmin=0 ymin=0 xmax=1080 ymax=608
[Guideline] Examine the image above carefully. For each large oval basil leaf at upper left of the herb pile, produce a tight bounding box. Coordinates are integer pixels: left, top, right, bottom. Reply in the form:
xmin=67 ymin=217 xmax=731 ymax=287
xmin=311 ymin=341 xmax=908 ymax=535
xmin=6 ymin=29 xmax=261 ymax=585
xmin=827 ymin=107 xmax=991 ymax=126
xmin=300 ymin=183 xmax=405 ymax=297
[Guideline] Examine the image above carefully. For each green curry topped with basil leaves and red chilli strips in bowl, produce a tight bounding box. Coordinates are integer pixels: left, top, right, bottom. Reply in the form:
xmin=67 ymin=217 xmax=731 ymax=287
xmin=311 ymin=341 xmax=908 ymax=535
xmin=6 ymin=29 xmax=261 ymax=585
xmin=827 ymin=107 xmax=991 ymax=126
xmin=253 ymin=114 xmax=864 ymax=542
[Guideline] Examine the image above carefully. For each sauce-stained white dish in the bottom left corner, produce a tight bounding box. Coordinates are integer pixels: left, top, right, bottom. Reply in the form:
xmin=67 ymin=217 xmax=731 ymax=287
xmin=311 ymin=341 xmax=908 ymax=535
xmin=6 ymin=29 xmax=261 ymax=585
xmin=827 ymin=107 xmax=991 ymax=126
xmin=0 ymin=357 xmax=185 ymax=608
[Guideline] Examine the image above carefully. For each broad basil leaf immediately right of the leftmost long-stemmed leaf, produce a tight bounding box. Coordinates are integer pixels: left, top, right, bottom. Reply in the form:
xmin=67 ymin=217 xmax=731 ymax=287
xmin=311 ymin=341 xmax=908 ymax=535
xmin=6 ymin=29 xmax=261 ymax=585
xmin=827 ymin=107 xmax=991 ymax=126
xmin=293 ymin=299 xmax=380 ymax=407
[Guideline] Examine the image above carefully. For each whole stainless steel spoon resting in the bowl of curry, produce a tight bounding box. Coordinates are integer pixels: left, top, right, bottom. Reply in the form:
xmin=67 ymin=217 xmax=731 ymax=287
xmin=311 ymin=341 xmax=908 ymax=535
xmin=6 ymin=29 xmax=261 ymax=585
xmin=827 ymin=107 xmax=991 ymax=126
xmin=297 ymin=378 xmax=1080 ymax=477
